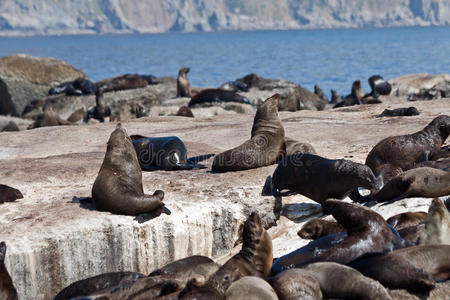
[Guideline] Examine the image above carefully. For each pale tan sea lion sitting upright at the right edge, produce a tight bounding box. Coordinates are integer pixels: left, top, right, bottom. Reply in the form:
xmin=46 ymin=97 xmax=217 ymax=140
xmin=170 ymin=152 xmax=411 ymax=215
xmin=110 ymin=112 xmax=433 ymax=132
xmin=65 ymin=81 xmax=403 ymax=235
xmin=419 ymin=198 xmax=450 ymax=245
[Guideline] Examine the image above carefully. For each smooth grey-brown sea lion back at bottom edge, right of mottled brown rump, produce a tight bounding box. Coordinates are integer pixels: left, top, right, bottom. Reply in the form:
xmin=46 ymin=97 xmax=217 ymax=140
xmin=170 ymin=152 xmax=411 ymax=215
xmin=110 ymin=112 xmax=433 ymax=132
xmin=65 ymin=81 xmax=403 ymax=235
xmin=304 ymin=262 xmax=392 ymax=300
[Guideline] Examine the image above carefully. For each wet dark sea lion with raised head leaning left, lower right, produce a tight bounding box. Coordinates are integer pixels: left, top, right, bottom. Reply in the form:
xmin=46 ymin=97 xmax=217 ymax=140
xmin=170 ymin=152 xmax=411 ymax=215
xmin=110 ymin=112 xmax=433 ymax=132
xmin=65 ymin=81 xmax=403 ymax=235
xmin=272 ymin=200 xmax=407 ymax=274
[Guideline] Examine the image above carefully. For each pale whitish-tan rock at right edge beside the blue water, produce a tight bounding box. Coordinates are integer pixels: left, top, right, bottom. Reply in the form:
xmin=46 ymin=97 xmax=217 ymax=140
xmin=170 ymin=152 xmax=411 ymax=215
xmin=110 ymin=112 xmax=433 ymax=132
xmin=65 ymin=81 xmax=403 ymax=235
xmin=389 ymin=74 xmax=450 ymax=101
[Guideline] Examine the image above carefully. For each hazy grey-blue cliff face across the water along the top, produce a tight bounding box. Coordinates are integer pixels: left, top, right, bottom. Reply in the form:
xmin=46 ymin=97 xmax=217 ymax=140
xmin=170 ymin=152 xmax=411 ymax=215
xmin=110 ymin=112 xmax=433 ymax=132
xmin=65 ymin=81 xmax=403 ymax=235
xmin=0 ymin=0 xmax=450 ymax=36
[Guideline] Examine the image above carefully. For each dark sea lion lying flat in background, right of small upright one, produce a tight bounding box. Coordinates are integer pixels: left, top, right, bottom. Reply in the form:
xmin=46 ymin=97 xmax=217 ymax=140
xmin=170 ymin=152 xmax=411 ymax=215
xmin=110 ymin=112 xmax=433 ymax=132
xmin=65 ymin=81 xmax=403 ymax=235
xmin=188 ymin=89 xmax=253 ymax=107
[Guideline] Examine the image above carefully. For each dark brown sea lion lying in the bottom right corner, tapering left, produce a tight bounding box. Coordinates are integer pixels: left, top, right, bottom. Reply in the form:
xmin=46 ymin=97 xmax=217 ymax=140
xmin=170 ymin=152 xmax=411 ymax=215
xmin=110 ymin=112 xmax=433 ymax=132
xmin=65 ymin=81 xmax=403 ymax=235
xmin=349 ymin=245 xmax=450 ymax=292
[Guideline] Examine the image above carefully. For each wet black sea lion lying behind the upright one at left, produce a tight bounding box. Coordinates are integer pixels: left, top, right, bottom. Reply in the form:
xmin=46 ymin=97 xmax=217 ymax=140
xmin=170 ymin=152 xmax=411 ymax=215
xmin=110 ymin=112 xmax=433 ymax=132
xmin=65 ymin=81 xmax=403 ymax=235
xmin=130 ymin=135 xmax=210 ymax=171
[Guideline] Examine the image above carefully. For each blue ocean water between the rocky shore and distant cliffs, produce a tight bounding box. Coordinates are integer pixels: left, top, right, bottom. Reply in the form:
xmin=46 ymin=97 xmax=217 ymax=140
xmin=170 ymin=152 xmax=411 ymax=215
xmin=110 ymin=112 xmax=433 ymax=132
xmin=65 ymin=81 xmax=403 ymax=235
xmin=0 ymin=27 xmax=450 ymax=95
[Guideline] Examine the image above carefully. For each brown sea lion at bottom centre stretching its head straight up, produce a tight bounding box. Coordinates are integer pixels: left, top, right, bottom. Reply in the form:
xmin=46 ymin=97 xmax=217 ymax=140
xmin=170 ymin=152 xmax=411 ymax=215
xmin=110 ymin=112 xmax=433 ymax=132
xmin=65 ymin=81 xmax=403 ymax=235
xmin=180 ymin=212 xmax=273 ymax=299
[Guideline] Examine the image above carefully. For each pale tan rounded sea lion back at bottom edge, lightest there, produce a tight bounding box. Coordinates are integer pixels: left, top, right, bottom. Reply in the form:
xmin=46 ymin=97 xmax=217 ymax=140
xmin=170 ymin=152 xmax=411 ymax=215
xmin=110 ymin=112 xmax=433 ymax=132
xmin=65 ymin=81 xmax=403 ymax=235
xmin=225 ymin=276 xmax=278 ymax=300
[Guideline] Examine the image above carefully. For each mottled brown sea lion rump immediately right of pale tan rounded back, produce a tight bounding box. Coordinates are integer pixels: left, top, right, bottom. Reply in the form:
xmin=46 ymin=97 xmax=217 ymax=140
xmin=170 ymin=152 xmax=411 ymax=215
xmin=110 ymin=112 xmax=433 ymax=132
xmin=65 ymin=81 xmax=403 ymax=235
xmin=267 ymin=268 xmax=322 ymax=300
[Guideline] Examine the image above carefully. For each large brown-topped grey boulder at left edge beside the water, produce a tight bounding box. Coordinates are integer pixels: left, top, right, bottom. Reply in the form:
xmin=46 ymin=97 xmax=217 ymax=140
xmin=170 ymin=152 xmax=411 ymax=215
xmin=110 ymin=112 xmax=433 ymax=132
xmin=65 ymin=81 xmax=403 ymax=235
xmin=0 ymin=54 xmax=86 ymax=116
